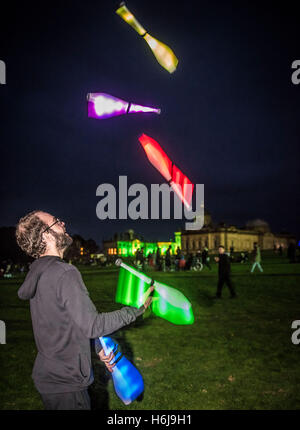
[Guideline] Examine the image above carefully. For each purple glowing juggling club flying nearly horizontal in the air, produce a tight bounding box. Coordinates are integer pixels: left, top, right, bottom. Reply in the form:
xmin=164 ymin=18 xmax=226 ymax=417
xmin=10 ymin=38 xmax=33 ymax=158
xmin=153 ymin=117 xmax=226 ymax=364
xmin=87 ymin=93 xmax=161 ymax=119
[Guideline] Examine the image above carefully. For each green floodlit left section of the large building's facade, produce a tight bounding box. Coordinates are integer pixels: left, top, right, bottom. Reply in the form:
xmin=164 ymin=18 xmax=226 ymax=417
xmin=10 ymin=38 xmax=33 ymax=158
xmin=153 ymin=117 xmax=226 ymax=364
xmin=106 ymin=232 xmax=181 ymax=257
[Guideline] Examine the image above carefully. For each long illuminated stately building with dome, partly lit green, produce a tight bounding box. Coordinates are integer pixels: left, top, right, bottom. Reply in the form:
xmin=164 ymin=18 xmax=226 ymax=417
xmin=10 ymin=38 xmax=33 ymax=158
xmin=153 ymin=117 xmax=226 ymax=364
xmin=103 ymin=210 xmax=296 ymax=257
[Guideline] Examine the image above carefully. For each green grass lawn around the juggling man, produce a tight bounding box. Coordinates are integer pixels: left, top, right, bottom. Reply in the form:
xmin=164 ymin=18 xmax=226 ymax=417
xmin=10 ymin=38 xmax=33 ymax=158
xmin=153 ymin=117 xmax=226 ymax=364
xmin=0 ymin=256 xmax=300 ymax=410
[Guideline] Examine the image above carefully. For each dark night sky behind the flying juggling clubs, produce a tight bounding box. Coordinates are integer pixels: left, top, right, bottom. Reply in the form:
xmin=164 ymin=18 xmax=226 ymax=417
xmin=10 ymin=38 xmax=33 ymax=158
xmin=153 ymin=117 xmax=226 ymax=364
xmin=0 ymin=0 xmax=300 ymax=244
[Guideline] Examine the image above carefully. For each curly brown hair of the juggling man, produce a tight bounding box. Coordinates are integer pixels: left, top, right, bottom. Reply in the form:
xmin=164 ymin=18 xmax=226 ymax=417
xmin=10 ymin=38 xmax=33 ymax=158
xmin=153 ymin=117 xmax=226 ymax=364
xmin=16 ymin=211 xmax=47 ymax=258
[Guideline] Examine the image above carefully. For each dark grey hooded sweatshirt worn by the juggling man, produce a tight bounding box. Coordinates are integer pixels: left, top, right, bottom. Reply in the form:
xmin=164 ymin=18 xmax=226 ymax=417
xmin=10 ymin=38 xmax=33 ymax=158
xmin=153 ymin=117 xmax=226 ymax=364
xmin=18 ymin=256 xmax=144 ymax=393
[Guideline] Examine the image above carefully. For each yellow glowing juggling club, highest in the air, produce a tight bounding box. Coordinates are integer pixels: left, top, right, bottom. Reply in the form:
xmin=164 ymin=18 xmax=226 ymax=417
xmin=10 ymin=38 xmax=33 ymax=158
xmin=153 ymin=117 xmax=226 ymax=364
xmin=116 ymin=2 xmax=178 ymax=73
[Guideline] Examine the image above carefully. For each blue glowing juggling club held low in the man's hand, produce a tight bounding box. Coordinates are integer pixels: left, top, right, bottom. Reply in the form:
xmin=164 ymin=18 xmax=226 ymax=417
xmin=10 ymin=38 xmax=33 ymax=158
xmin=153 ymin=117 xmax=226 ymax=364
xmin=99 ymin=336 xmax=144 ymax=405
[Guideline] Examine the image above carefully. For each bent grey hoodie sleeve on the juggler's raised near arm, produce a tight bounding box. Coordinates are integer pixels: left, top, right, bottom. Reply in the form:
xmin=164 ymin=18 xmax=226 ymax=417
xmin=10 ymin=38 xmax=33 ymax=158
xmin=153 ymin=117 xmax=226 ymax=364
xmin=57 ymin=267 xmax=145 ymax=339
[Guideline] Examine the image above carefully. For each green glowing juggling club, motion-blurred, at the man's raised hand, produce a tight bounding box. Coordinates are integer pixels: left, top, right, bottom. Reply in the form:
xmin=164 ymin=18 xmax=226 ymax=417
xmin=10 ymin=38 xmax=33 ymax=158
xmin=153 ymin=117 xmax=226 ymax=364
xmin=116 ymin=259 xmax=194 ymax=324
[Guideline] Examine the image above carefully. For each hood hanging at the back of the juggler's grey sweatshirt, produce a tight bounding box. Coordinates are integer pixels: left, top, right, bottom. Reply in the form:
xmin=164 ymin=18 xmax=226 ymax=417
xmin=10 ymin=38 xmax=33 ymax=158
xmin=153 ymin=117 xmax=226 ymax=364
xmin=18 ymin=255 xmax=62 ymax=300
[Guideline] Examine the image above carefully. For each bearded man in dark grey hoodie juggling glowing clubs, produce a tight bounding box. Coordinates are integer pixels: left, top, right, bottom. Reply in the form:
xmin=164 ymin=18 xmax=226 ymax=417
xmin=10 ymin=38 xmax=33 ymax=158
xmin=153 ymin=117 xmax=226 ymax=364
xmin=16 ymin=211 xmax=152 ymax=410
